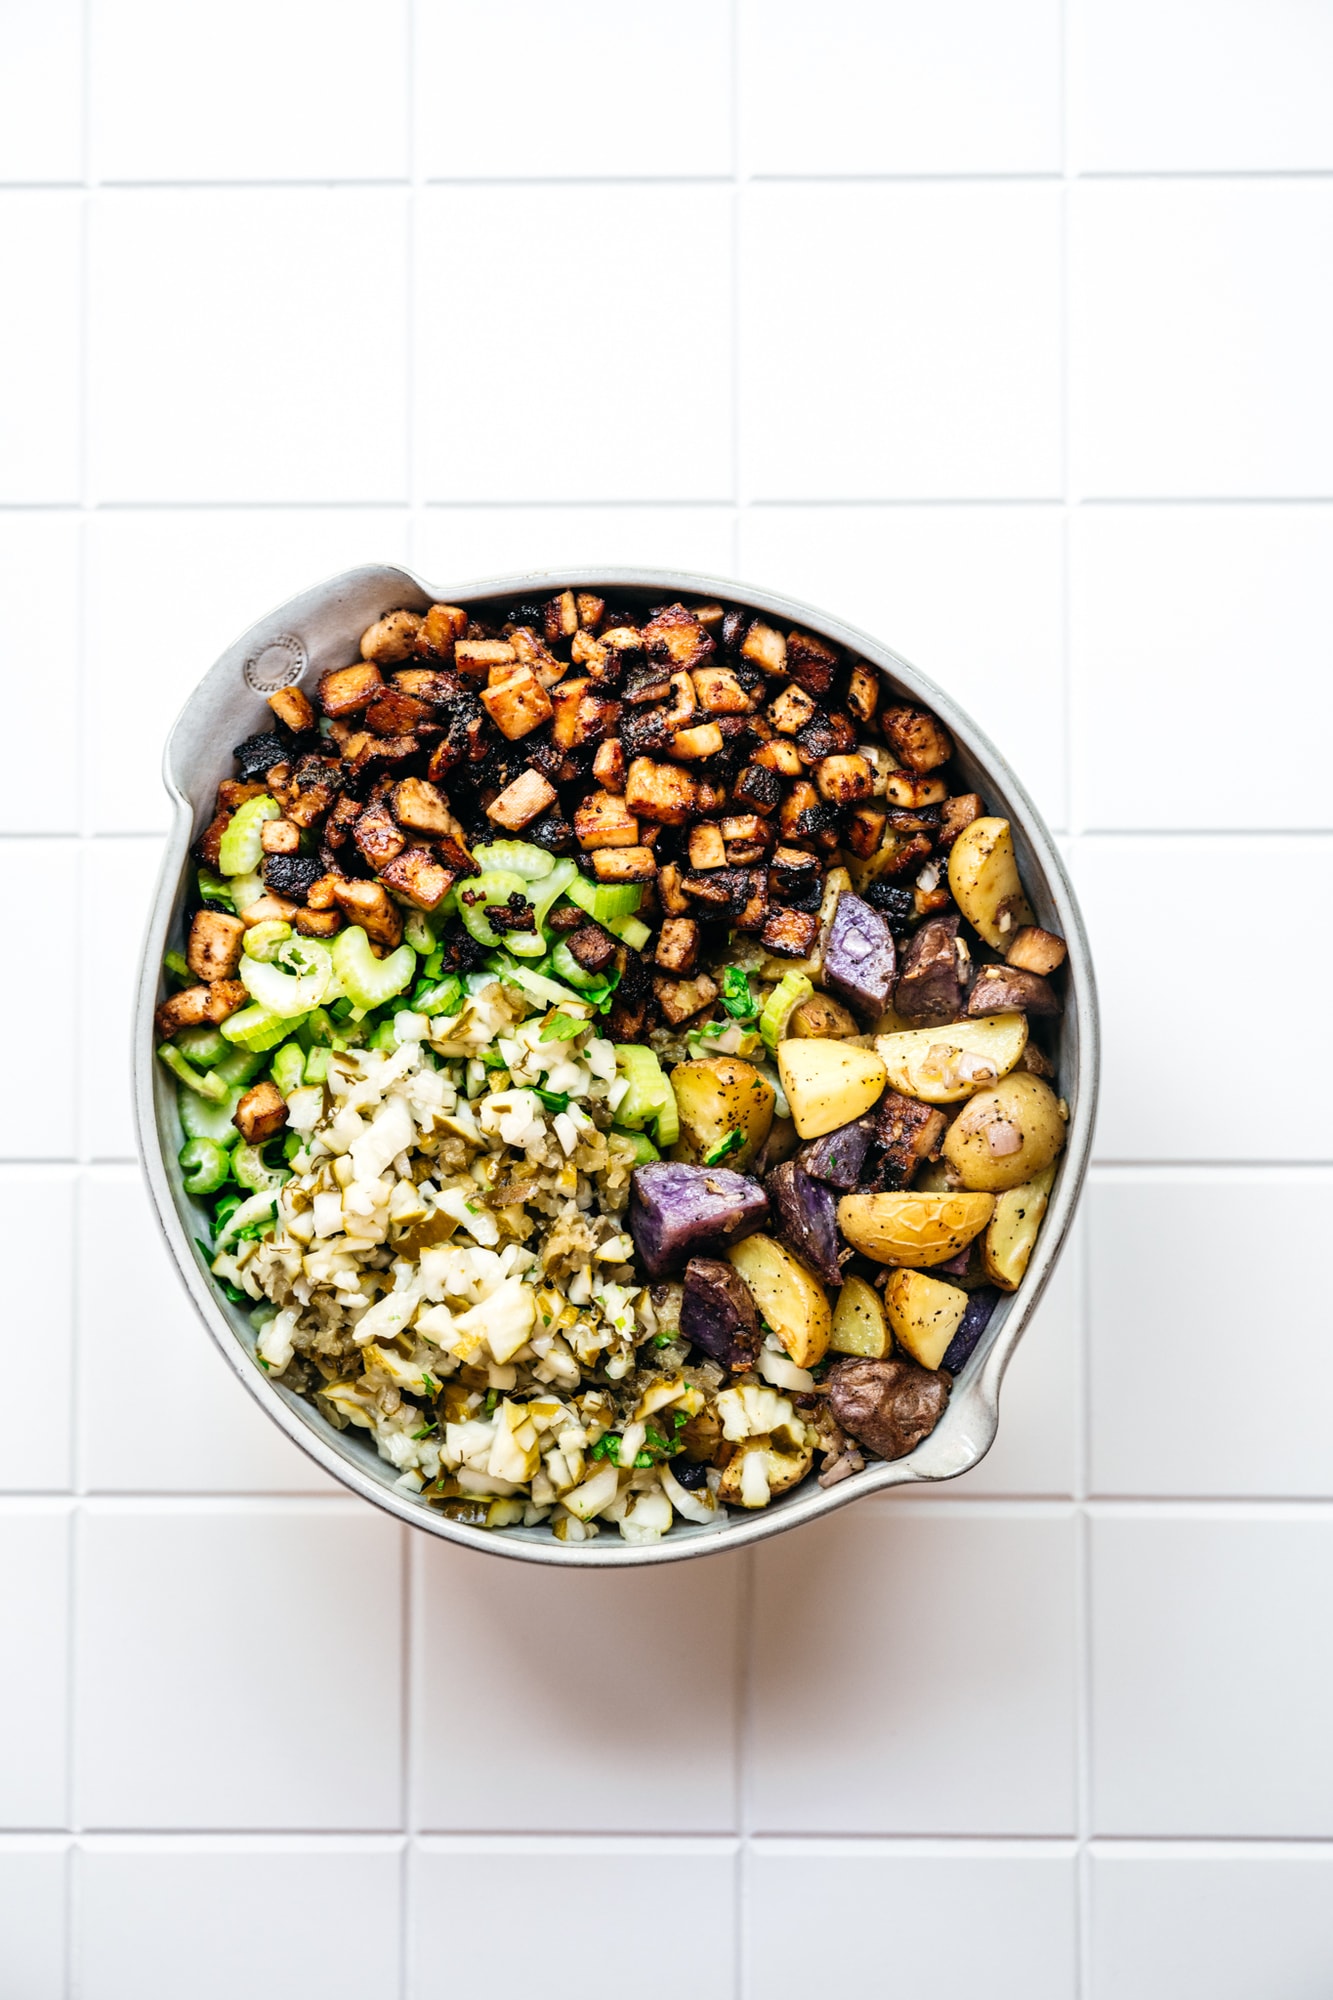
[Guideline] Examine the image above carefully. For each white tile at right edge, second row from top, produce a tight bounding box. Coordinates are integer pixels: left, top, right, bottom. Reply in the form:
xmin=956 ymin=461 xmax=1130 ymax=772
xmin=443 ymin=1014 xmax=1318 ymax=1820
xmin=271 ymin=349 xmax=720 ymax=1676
xmin=1071 ymin=180 xmax=1333 ymax=500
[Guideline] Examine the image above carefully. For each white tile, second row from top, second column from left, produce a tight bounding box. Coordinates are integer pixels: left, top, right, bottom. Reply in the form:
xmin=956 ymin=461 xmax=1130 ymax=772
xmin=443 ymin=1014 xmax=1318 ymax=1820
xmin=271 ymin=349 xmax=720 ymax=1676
xmin=88 ymin=188 xmax=406 ymax=502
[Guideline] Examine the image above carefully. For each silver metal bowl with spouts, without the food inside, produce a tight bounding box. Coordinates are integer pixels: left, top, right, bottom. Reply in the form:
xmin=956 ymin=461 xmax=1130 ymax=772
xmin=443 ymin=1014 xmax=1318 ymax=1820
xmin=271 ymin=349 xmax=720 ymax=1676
xmin=134 ymin=566 xmax=1097 ymax=1568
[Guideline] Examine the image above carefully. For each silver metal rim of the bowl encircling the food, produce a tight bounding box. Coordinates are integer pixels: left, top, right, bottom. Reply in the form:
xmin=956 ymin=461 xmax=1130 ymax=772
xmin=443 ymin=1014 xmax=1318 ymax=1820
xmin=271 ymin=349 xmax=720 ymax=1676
xmin=132 ymin=562 xmax=1101 ymax=1570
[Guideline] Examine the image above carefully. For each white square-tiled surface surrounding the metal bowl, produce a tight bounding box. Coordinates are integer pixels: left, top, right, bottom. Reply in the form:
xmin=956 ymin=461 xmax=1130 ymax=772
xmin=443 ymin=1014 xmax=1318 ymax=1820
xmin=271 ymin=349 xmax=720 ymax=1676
xmin=0 ymin=0 xmax=1333 ymax=2000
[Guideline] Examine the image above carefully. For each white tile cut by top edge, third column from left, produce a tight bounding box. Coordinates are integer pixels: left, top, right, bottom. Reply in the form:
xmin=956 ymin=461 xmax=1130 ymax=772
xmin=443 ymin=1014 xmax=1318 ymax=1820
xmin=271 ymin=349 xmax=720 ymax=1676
xmin=412 ymin=0 xmax=733 ymax=182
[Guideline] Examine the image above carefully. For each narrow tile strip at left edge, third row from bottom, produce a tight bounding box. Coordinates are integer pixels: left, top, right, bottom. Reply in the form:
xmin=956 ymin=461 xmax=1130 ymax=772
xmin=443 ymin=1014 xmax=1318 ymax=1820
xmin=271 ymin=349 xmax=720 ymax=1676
xmin=0 ymin=1166 xmax=76 ymax=1492
